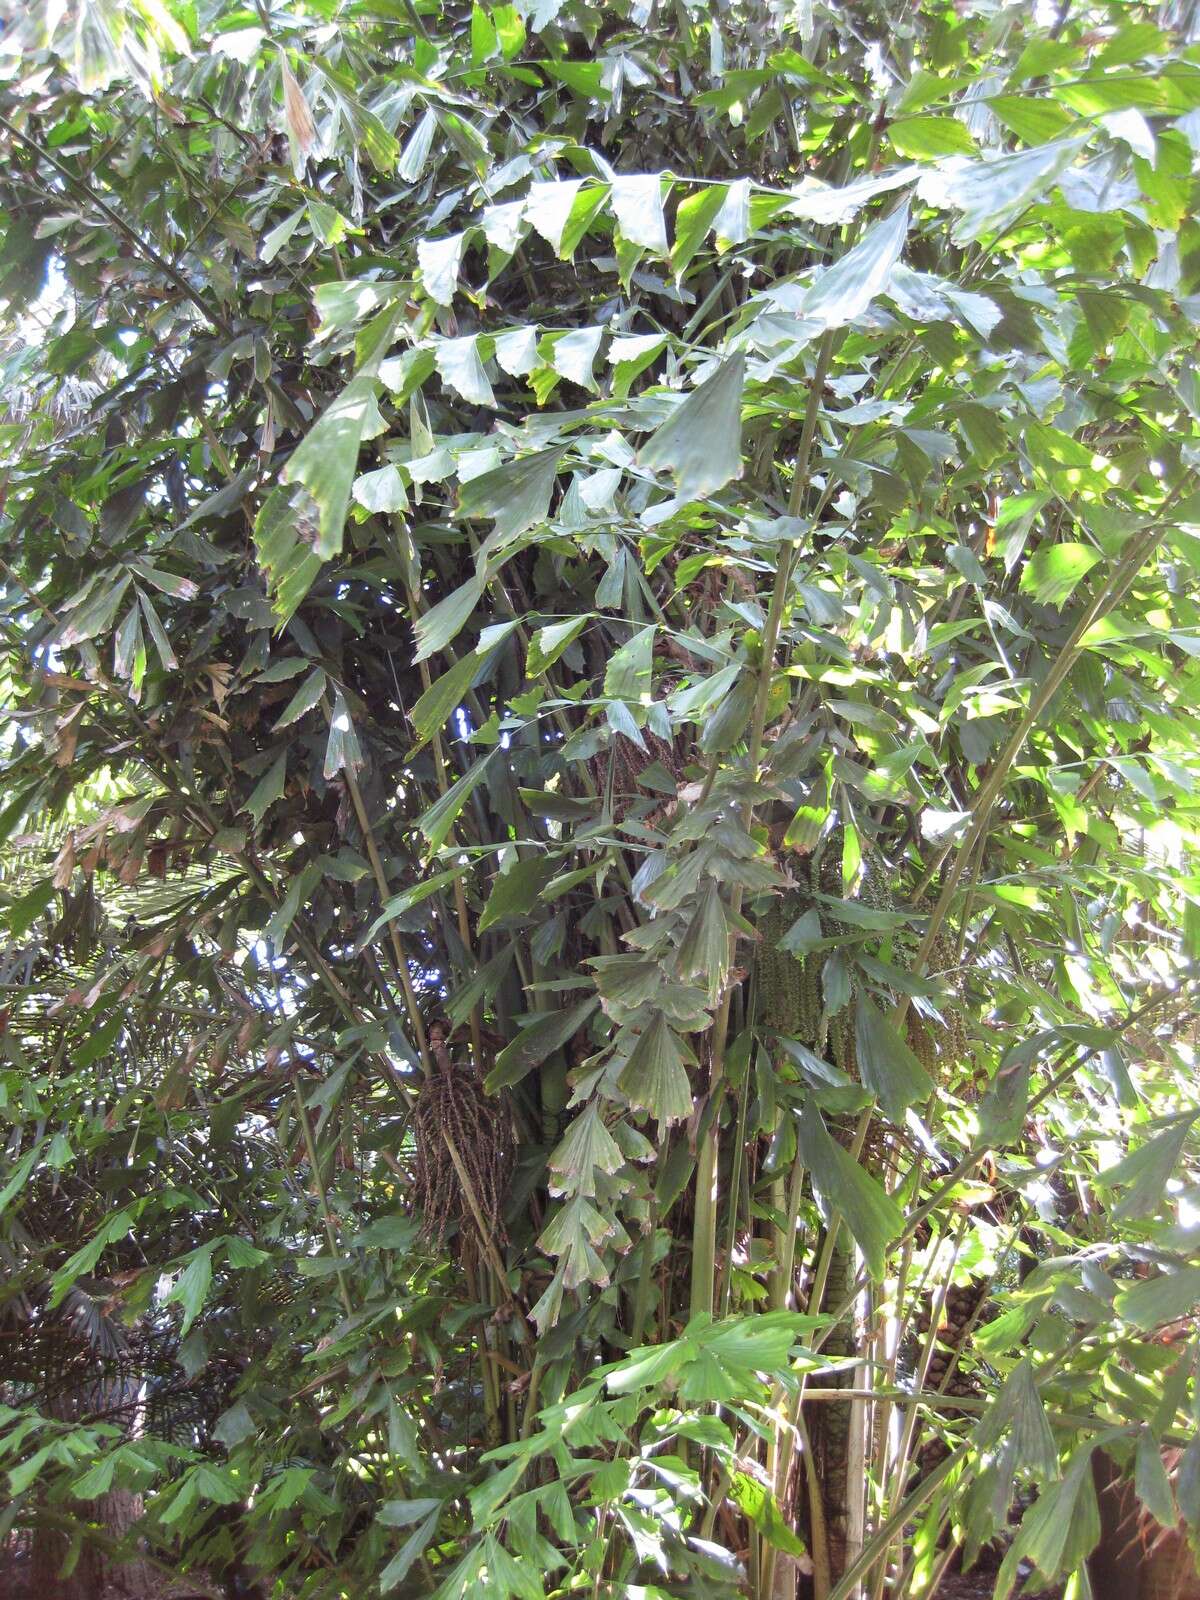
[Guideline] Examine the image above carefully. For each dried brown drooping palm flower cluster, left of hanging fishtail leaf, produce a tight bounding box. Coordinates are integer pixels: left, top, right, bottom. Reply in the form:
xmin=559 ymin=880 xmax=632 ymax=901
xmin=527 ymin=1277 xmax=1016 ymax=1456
xmin=413 ymin=1021 xmax=514 ymax=1256
